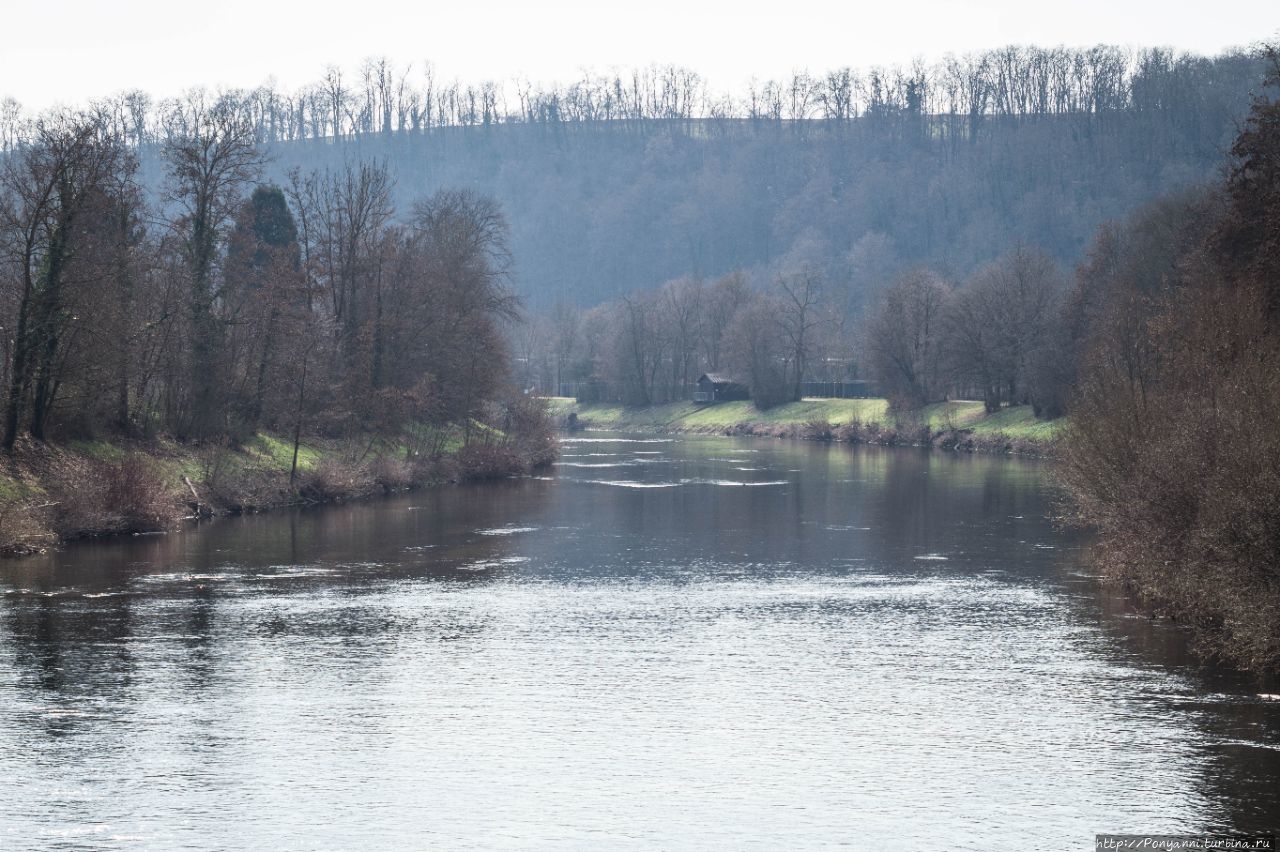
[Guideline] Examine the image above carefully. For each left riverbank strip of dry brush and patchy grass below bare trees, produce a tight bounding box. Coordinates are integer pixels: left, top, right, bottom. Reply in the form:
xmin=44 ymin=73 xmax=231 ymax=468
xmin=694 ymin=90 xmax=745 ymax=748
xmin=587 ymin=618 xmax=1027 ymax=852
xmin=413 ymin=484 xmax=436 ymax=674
xmin=0 ymin=425 xmax=554 ymax=555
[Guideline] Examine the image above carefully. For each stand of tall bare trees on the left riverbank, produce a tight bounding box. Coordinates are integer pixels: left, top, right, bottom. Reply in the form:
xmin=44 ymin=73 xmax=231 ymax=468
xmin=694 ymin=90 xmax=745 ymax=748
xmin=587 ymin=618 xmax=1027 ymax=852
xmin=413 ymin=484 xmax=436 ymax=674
xmin=0 ymin=93 xmax=550 ymax=488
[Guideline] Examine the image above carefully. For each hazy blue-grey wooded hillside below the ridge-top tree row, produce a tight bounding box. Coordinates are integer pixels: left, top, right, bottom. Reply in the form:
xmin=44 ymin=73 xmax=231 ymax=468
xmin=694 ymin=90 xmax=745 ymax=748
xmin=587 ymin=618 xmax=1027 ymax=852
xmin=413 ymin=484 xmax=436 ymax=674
xmin=235 ymin=47 xmax=1261 ymax=305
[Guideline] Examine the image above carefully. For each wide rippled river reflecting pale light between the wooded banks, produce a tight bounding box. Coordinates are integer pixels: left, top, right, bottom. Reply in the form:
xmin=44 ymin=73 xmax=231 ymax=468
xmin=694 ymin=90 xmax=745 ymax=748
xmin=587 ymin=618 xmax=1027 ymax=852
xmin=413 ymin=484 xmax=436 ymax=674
xmin=0 ymin=435 xmax=1280 ymax=851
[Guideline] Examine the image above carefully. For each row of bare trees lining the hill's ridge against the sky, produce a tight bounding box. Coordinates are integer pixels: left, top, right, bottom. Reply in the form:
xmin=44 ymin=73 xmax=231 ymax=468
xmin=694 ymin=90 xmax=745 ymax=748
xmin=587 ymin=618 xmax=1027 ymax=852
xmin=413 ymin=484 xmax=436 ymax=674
xmin=0 ymin=45 xmax=1258 ymax=145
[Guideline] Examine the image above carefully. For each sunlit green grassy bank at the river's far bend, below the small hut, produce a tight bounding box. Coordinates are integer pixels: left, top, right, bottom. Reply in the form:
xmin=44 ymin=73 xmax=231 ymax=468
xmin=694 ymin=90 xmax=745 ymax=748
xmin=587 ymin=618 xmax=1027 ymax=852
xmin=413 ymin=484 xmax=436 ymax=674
xmin=548 ymin=398 xmax=1064 ymax=455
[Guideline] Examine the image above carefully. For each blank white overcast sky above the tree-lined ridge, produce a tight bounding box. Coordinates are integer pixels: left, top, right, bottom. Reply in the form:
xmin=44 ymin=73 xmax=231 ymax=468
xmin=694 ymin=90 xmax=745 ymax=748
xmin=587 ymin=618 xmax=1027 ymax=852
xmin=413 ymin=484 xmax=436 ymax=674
xmin=0 ymin=0 xmax=1280 ymax=109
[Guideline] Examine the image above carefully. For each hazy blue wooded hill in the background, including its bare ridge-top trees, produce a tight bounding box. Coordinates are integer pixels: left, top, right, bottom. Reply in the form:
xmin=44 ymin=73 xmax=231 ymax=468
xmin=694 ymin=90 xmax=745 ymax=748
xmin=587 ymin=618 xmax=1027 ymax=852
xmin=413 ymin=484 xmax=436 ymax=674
xmin=10 ymin=46 xmax=1263 ymax=305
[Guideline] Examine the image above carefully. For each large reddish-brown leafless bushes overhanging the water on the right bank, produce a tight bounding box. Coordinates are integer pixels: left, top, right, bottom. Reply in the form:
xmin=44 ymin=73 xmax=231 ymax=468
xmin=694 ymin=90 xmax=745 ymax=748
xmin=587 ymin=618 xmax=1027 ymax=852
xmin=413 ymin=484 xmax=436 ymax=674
xmin=1061 ymin=283 xmax=1280 ymax=669
